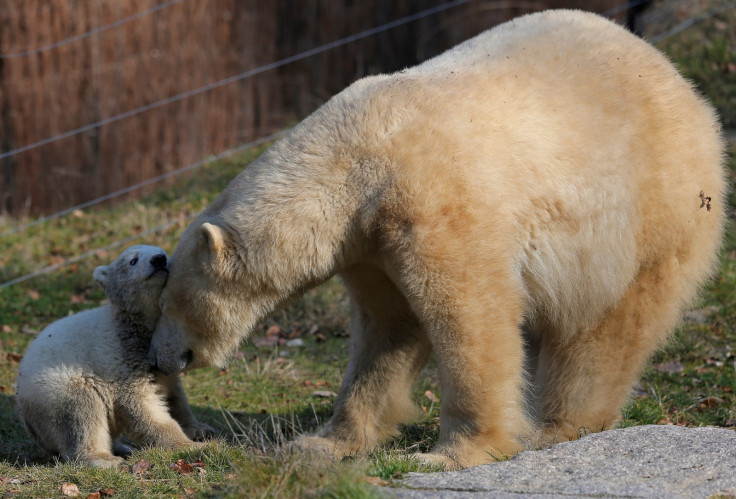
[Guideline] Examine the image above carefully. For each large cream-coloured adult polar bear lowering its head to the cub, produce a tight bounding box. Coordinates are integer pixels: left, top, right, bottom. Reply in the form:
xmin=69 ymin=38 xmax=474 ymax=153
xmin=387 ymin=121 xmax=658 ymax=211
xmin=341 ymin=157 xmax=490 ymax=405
xmin=149 ymin=11 xmax=725 ymax=466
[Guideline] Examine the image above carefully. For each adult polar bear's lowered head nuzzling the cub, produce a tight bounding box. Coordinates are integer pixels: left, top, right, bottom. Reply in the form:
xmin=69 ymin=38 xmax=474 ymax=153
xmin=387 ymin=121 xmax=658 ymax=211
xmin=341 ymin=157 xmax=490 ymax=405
xmin=148 ymin=219 xmax=268 ymax=374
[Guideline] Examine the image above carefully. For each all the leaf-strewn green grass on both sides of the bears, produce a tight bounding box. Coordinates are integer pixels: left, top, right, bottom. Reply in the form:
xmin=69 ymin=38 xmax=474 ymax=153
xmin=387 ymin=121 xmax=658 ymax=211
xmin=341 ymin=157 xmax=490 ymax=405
xmin=0 ymin=2 xmax=736 ymax=497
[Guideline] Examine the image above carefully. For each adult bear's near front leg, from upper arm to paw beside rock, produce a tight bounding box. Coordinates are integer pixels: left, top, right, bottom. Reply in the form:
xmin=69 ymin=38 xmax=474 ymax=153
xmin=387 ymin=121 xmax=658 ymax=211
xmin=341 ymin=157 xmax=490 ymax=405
xmin=398 ymin=214 xmax=533 ymax=468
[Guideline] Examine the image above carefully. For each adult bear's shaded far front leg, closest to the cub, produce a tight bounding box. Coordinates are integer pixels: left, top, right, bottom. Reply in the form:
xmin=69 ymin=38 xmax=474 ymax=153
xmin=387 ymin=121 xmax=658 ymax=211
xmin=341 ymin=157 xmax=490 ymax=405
xmin=298 ymin=265 xmax=431 ymax=458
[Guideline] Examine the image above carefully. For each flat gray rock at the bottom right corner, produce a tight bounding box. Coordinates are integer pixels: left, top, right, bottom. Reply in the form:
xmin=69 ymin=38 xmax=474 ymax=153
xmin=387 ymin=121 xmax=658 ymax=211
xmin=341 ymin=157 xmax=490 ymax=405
xmin=394 ymin=425 xmax=736 ymax=499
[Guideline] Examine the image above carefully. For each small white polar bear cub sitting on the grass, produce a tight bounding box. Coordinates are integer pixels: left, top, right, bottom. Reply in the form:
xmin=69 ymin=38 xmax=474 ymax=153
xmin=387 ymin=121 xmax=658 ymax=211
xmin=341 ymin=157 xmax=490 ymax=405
xmin=16 ymin=245 xmax=214 ymax=468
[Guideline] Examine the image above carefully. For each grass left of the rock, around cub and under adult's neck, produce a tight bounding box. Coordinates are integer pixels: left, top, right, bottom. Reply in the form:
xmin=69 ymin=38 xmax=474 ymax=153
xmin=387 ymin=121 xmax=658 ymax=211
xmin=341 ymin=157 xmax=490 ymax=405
xmin=0 ymin=149 xmax=439 ymax=497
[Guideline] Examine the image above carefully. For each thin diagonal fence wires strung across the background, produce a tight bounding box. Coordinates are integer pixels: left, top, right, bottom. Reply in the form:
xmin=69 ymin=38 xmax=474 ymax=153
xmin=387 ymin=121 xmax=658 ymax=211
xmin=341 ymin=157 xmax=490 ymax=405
xmin=0 ymin=0 xmax=724 ymax=289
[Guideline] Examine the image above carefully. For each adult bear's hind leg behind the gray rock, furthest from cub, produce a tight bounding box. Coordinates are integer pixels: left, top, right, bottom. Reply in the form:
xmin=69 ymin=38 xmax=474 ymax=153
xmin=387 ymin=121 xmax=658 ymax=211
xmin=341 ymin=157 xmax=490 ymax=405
xmin=538 ymin=256 xmax=708 ymax=445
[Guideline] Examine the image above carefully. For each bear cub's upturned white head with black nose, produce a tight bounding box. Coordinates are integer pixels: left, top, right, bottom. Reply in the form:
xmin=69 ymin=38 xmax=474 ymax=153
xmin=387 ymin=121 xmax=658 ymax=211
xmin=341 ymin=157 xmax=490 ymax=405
xmin=93 ymin=244 xmax=169 ymax=325
